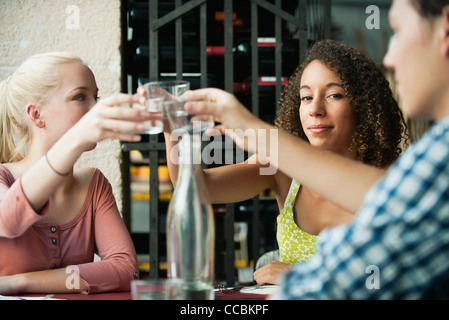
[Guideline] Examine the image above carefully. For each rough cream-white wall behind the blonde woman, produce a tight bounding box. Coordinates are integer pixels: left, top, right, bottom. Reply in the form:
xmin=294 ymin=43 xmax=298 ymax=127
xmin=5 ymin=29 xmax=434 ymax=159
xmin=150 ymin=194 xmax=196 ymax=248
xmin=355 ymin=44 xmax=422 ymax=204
xmin=0 ymin=0 xmax=126 ymax=215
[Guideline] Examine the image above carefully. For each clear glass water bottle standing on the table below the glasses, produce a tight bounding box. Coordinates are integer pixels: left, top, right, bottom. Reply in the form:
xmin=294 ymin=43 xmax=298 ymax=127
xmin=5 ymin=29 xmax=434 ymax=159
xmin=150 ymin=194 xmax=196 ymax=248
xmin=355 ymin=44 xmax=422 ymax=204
xmin=167 ymin=131 xmax=215 ymax=300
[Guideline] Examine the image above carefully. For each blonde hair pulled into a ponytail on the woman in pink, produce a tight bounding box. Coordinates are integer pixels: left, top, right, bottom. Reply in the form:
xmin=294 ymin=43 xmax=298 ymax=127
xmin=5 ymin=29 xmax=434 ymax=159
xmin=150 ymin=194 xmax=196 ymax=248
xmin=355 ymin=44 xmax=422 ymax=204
xmin=0 ymin=52 xmax=84 ymax=163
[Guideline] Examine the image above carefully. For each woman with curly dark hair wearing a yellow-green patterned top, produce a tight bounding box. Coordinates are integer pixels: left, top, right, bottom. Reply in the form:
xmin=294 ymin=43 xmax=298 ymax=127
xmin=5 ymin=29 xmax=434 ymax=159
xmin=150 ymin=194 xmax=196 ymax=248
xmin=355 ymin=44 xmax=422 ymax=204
xmin=167 ymin=40 xmax=405 ymax=283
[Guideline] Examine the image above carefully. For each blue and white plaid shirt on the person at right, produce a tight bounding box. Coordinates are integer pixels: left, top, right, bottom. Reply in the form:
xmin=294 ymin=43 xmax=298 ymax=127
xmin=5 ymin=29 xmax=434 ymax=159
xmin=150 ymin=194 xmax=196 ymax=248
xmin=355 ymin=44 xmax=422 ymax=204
xmin=275 ymin=117 xmax=449 ymax=299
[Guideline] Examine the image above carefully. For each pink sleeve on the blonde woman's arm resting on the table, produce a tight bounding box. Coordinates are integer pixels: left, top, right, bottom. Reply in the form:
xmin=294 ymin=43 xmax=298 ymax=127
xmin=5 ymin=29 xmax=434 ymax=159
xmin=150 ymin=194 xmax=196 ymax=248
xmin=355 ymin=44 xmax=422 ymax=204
xmin=77 ymin=173 xmax=139 ymax=293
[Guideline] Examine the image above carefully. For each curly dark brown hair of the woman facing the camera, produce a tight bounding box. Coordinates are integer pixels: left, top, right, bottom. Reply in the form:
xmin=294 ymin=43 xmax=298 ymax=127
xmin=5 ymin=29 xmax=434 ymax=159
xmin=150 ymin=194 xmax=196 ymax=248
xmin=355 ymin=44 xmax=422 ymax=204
xmin=275 ymin=40 xmax=407 ymax=168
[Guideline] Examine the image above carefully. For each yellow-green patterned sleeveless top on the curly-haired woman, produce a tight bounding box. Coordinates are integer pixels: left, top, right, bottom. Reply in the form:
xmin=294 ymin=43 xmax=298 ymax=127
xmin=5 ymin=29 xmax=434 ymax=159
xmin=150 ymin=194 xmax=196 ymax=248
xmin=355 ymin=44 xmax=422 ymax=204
xmin=276 ymin=180 xmax=318 ymax=264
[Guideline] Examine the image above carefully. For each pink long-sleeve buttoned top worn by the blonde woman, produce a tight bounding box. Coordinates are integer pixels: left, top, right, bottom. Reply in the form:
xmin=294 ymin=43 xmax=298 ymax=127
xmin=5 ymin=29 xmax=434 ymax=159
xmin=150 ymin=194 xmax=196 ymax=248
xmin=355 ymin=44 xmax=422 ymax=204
xmin=0 ymin=165 xmax=139 ymax=293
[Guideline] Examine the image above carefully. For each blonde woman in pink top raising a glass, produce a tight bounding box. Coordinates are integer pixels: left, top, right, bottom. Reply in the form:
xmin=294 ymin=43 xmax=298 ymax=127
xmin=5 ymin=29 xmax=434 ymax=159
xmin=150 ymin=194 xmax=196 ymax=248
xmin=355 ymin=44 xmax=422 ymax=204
xmin=0 ymin=53 xmax=147 ymax=294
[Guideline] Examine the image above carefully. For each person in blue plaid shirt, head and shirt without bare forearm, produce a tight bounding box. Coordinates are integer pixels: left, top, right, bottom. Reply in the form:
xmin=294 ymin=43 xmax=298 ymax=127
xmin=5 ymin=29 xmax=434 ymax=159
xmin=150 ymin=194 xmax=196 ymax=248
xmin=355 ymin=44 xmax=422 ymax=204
xmin=276 ymin=0 xmax=449 ymax=299
